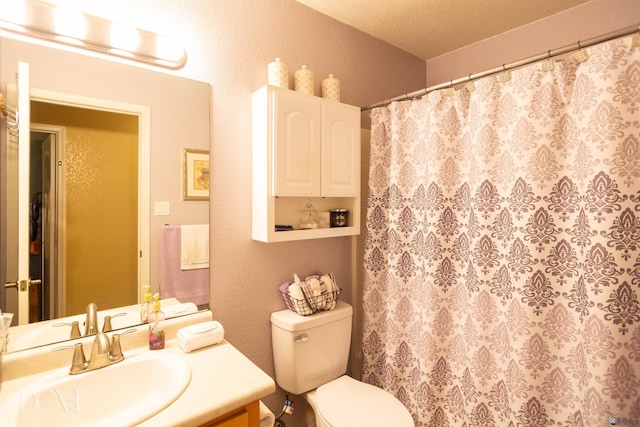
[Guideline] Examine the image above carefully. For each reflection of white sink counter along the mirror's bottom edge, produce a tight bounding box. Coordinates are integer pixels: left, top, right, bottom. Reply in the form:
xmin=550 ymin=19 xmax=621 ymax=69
xmin=9 ymin=310 xmax=140 ymax=351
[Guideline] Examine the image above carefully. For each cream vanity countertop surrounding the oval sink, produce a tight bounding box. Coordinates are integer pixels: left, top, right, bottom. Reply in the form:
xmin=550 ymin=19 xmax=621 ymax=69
xmin=0 ymin=312 xmax=275 ymax=427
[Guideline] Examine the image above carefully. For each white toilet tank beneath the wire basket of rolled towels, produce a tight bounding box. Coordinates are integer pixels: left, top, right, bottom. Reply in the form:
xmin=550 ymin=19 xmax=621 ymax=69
xmin=271 ymin=301 xmax=353 ymax=394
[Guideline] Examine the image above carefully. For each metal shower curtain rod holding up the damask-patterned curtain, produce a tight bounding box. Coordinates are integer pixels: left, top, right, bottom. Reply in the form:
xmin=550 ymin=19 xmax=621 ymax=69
xmin=362 ymin=24 xmax=640 ymax=111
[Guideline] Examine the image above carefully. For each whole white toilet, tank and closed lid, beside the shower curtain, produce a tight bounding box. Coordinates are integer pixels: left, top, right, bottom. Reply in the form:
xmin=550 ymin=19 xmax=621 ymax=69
xmin=271 ymin=301 xmax=414 ymax=427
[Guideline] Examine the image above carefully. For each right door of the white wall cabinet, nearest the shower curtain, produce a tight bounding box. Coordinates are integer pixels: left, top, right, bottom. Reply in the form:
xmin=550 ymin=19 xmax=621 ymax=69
xmin=321 ymin=102 xmax=360 ymax=197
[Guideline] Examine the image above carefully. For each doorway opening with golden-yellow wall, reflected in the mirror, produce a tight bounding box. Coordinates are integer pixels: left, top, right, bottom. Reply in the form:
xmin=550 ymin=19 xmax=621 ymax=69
xmin=31 ymin=101 xmax=138 ymax=317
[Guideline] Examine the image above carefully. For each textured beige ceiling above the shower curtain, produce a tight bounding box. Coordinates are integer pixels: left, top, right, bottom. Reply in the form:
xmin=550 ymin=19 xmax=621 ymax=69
xmin=297 ymin=0 xmax=589 ymax=60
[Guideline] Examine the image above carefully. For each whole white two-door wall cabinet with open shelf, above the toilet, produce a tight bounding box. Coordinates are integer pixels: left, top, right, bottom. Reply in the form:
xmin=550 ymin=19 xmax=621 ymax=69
xmin=252 ymin=85 xmax=361 ymax=242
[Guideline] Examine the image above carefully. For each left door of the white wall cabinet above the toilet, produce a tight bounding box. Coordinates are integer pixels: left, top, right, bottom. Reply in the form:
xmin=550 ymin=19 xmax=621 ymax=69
xmin=273 ymin=92 xmax=322 ymax=197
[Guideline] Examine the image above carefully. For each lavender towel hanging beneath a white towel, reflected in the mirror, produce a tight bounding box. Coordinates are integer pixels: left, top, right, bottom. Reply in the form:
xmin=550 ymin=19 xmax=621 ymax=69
xmin=160 ymin=226 xmax=209 ymax=305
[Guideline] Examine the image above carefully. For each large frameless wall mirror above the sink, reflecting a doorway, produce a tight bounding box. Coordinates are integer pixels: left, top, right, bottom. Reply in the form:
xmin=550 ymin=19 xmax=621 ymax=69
xmin=0 ymin=37 xmax=211 ymax=350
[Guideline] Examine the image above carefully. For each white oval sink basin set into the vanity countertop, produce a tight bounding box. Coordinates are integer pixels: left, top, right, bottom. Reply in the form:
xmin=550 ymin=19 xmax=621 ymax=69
xmin=0 ymin=350 xmax=191 ymax=427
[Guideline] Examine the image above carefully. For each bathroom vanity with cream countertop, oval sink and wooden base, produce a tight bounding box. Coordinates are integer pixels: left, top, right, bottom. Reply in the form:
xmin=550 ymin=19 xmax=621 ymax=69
xmin=0 ymin=311 xmax=275 ymax=427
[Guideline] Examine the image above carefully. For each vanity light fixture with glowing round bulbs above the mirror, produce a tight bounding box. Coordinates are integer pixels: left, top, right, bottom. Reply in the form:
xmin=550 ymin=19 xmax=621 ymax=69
xmin=0 ymin=0 xmax=187 ymax=69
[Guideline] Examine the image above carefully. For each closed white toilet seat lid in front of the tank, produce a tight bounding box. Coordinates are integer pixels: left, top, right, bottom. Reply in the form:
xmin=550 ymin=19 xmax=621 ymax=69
xmin=316 ymin=375 xmax=414 ymax=427
